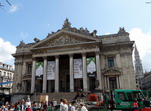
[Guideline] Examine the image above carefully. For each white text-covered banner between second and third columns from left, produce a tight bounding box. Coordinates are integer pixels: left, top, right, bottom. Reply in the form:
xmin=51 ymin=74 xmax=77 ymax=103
xmin=47 ymin=61 xmax=56 ymax=80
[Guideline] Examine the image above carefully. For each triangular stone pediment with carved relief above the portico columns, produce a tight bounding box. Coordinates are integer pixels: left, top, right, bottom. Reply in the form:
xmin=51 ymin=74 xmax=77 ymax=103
xmin=32 ymin=30 xmax=101 ymax=49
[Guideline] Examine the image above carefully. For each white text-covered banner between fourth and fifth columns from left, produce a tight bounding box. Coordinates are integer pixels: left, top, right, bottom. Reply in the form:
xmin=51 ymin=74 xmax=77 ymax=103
xmin=74 ymin=59 xmax=82 ymax=79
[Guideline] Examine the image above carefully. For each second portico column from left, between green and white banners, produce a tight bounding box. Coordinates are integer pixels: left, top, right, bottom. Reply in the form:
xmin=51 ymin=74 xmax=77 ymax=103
xmin=42 ymin=57 xmax=47 ymax=93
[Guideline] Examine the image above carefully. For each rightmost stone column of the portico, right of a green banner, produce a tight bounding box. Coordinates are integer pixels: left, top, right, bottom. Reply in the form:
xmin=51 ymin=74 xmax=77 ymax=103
xmin=95 ymin=52 xmax=102 ymax=89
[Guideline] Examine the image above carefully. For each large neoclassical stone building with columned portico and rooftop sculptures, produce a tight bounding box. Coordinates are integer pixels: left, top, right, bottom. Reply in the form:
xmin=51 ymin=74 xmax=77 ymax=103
xmin=12 ymin=19 xmax=136 ymax=97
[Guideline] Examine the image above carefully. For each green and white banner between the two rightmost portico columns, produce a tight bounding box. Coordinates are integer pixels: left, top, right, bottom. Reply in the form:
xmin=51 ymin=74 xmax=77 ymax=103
xmin=87 ymin=57 xmax=96 ymax=77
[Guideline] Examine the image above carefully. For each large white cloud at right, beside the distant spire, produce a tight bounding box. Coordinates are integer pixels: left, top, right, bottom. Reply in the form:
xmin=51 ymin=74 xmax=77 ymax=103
xmin=129 ymin=28 xmax=151 ymax=71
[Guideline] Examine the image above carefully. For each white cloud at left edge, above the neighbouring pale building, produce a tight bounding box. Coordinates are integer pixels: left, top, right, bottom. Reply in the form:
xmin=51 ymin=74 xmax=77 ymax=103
xmin=0 ymin=38 xmax=16 ymax=66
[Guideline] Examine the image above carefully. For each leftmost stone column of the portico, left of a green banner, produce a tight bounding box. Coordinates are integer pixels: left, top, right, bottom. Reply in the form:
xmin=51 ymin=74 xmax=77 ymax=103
xmin=31 ymin=59 xmax=36 ymax=93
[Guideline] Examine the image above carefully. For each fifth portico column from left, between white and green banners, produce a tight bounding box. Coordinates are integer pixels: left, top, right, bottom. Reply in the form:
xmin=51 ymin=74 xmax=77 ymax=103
xmin=82 ymin=53 xmax=88 ymax=91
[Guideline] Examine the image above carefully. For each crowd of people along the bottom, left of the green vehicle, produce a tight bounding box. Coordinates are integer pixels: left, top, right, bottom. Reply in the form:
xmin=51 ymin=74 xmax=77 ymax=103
xmin=0 ymin=98 xmax=88 ymax=111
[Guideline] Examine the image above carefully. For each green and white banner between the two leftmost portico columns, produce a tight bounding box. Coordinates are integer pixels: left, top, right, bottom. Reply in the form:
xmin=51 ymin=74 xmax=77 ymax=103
xmin=36 ymin=62 xmax=44 ymax=79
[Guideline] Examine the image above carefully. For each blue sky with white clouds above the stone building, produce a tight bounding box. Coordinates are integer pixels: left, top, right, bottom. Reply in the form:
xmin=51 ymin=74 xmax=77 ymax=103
xmin=0 ymin=0 xmax=151 ymax=72
